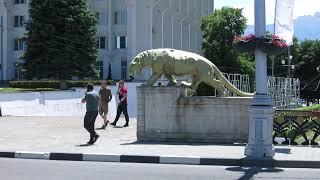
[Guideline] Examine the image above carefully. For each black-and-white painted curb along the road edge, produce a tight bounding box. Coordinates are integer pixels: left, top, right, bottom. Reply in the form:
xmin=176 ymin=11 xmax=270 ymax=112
xmin=0 ymin=151 xmax=320 ymax=168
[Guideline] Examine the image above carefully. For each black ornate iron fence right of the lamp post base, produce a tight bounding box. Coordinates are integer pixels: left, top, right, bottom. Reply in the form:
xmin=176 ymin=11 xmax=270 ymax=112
xmin=273 ymin=110 xmax=320 ymax=146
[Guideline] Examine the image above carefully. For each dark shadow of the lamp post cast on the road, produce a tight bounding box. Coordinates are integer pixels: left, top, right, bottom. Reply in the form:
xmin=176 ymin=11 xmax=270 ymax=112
xmin=226 ymin=167 xmax=283 ymax=180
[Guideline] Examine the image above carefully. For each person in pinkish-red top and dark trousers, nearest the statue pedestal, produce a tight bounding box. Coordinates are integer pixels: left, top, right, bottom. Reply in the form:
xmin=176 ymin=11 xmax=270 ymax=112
xmin=111 ymin=80 xmax=129 ymax=127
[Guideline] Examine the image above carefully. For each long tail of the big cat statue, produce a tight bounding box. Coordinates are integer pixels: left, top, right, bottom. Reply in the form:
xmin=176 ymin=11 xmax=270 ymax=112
xmin=213 ymin=65 xmax=254 ymax=97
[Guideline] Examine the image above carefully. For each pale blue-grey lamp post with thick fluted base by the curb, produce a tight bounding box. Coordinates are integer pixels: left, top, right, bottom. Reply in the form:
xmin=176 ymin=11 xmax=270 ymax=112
xmin=245 ymin=0 xmax=274 ymax=158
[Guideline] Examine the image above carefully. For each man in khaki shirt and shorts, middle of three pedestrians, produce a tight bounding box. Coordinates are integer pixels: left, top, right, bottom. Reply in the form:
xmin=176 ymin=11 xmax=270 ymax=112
xmin=99 ymin=81 xmax=112 ymax=129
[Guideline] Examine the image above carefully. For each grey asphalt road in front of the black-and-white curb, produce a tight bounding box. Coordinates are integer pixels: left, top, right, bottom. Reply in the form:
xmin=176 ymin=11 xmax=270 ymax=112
xmin=0 ymin=158 xmax=320 ymax=180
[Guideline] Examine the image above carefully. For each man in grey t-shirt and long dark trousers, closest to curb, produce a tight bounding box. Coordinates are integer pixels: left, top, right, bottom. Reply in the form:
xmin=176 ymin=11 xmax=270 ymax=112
xmin=82 ymin=83 xmax=100 ymax=144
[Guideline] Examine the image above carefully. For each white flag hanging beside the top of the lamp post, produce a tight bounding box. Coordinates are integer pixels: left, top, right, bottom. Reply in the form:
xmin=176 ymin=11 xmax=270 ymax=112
xmin=274 ymin=0 xmax=294 ymax=46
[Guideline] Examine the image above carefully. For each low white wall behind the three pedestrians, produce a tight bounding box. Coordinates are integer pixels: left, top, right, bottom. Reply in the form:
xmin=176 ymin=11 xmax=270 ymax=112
xmin=0 ymin=83 xmax=141 ymax=116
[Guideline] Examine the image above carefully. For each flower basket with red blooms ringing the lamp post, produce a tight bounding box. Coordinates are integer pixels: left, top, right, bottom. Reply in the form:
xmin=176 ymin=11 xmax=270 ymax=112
xmin=234 ymin=34 xmax=288 ymax=55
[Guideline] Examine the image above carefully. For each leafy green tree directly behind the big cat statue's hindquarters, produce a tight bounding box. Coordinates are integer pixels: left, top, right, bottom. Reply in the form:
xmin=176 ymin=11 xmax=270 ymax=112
xmin=197 ymin=7 xmax=255 ymax=95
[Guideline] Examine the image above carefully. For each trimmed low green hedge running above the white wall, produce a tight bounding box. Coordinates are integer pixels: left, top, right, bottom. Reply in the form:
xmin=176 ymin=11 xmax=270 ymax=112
xmin=9 ymin=80 xmax=115 ymax=89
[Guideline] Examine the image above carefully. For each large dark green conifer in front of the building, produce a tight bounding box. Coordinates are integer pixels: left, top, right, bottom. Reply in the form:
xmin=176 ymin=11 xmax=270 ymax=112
xmin=23 ymin=0 xmax=98 ymax=79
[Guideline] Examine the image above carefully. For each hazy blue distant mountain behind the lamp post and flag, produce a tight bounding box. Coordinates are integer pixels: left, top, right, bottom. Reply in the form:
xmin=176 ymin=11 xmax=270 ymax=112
xmin=245 ymin=12 xmax=320 ymax=40
